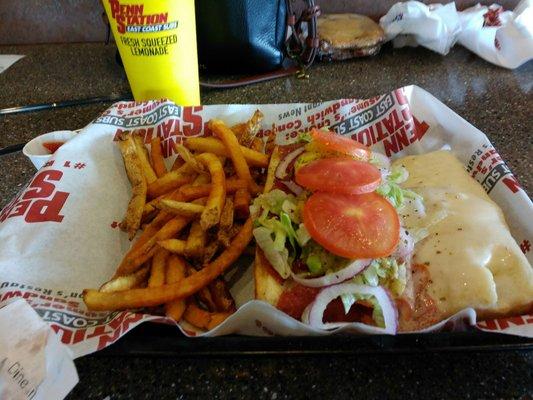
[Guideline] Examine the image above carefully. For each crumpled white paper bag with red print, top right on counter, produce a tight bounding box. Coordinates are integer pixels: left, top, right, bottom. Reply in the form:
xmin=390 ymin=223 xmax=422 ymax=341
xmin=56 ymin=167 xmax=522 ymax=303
xmin=380 ymin=0 xmax=533 ymax=69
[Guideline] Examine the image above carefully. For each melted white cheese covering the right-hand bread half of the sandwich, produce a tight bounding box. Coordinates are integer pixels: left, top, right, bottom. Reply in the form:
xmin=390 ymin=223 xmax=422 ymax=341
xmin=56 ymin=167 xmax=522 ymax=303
xmin=397 ymin=151 xmax=533 ymax=316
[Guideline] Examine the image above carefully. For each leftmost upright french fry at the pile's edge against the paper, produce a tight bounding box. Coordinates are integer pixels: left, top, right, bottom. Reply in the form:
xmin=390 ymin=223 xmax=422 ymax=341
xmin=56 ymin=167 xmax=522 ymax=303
xmin=118 ymin=134 xmax=147 ymax=240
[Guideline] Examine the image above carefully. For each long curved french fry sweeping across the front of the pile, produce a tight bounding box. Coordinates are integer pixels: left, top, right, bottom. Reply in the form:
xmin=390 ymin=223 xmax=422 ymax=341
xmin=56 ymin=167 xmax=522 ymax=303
xmin=83 ymin=218 xmax=253 ymax=311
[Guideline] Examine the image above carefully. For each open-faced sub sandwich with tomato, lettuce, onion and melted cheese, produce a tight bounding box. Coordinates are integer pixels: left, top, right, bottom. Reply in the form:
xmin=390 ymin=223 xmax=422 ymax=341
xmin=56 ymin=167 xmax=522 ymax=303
xmin=251 ymin=130 xmax=533 ymax=334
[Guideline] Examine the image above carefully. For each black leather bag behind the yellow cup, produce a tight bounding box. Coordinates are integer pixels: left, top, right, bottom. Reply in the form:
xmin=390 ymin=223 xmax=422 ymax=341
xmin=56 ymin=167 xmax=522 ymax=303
xmin=196 ymin=0 xmax=319 ymax=73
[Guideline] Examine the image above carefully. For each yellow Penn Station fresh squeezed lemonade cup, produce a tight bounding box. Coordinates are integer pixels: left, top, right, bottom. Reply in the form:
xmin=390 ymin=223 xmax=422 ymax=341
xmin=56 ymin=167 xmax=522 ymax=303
xmin=102 ymin=0 xmax=200 ymax=106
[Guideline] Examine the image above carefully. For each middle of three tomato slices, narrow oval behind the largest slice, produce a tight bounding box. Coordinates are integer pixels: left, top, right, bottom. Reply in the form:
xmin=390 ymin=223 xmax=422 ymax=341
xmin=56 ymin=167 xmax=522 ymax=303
xmin=295 ymin=158 xmax=381 ymax=194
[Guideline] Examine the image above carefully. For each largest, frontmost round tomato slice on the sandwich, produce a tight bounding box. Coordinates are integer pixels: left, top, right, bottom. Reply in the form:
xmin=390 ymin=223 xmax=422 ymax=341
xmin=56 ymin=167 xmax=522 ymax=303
xmin=303 ymin=192 xmax=400 ymax=258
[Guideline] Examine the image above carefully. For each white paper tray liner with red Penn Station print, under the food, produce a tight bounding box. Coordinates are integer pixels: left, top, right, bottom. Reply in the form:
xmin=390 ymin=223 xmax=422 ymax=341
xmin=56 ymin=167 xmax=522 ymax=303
xmin=0 ymin=86 xmax=533 ymax=356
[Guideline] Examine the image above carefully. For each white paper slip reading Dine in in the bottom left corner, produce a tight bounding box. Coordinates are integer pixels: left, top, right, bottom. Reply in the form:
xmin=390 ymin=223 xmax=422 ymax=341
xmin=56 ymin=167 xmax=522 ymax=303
xmin=0 ymin=299 xmax=78 ymax=400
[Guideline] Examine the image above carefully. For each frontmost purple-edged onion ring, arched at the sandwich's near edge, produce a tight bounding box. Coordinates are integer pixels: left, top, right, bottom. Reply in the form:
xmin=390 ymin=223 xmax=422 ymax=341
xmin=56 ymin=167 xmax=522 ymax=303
xmin=302 ymin=283 xmax=398 ymax=335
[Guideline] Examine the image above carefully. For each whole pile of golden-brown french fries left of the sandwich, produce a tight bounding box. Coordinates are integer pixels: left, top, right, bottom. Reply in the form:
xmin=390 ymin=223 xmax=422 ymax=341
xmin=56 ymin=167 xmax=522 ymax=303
xmin=83 ymin=111 xmax=274 ymax=329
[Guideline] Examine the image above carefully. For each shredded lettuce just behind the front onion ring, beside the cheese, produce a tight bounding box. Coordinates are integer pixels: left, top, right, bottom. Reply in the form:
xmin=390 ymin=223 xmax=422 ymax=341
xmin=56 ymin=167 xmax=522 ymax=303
xmin=353 ymin=257 xmax=407 ymax=296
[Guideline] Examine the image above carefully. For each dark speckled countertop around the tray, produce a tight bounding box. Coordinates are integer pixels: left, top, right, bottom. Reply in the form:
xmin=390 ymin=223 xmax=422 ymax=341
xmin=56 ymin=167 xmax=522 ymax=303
xmin=0 ymin=44 xmax=533 ymax=399
